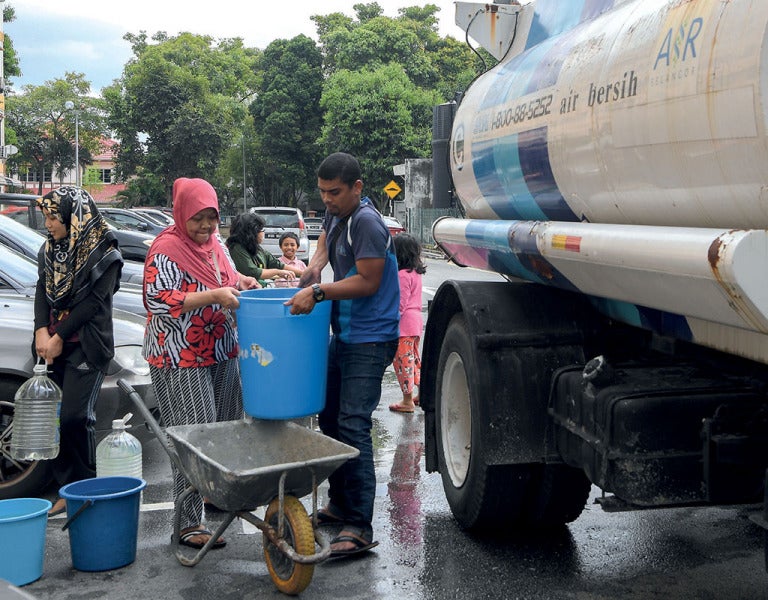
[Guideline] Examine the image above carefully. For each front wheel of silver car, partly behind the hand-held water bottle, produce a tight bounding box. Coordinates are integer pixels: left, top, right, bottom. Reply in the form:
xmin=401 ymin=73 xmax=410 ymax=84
xmin=0 ymin=378 xmax=51 ymax=500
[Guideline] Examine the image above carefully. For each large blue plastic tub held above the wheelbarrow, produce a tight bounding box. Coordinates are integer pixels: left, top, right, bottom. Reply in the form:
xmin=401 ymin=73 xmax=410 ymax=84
xmin=237 ymin=288 xmax=331 ymax=419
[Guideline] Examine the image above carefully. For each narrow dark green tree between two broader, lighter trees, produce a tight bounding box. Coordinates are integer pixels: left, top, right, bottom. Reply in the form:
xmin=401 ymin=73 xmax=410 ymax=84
xmin=250 ymin=35 xmax=323 ymax=206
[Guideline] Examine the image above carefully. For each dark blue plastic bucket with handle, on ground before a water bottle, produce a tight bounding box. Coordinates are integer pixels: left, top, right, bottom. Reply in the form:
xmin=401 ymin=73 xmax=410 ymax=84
xmin=59 ymin=477 xmax=147 ymax=571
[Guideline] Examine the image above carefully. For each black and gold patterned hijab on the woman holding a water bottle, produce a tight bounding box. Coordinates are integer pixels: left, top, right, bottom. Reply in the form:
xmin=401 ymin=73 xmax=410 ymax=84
xmin=37 ymin=186 xmax=122 ymax=310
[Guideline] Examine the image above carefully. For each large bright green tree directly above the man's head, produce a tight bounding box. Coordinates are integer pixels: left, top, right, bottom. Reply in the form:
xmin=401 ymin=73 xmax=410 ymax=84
xmin=312 ymin=2 xmax=481 ymax=207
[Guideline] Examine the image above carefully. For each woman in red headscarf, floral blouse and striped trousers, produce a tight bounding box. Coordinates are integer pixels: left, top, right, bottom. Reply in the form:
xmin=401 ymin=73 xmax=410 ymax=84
xmin=144 ymin=177 xmax=258 ymax=548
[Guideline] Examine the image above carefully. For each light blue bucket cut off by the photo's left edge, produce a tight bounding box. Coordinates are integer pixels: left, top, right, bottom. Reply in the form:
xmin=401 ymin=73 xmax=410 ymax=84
xmin=0 ymin=498 xmax=51 ymax=585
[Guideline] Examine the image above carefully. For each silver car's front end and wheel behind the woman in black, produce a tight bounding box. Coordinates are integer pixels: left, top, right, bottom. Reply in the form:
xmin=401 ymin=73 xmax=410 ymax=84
xmin=0 ymin=291 xmax=157 ymax=499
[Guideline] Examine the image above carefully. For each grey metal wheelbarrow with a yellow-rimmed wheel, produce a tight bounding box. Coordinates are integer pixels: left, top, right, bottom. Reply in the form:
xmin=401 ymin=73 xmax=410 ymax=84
xmin=117 ymin=379 xmax=359 ymax=595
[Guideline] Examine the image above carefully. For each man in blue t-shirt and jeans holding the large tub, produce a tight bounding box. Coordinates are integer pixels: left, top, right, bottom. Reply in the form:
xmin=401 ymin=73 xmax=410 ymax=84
xmin=287 ymin=152 xmax=400 ymax=556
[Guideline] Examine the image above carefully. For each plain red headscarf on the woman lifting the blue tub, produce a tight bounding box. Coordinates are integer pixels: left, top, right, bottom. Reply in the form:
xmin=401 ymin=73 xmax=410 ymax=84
xmin=145 ymin=177 xmax=239 ymax=289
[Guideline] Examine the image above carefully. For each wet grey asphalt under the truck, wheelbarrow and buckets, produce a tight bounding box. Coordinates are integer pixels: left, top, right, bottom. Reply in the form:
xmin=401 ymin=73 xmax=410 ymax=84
xmin=12 ymin=372 xmax=768 ymax=600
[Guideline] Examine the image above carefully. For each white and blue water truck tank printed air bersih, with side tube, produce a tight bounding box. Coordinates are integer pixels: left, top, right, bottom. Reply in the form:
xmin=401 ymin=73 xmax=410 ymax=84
xmin=433 ymin=0 xmax=768 ymax=362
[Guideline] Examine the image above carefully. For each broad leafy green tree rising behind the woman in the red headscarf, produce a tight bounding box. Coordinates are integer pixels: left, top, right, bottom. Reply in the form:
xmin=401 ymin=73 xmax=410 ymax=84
xmin=104 ymin=32 xmax=258 ymax=203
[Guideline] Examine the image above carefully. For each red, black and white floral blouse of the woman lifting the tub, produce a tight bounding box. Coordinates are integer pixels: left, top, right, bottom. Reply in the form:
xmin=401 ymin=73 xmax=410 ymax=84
xmin=143 ymin=254 xmax=237 ymax=368
